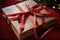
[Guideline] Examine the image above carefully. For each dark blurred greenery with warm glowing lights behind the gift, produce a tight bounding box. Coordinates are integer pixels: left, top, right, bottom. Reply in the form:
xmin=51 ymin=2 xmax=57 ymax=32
xmin=34 ymin=0 xmax=60 ymax=13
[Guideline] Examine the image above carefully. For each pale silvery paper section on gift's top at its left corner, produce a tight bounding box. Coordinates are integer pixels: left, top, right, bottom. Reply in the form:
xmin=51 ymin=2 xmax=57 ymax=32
xmin=2 ymin=5 xmax=20 ymax=15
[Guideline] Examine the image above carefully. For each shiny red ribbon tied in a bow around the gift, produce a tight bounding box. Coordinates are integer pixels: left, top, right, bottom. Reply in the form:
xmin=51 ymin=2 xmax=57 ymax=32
xmin=8 ymin=4 xmax=59 ymax=40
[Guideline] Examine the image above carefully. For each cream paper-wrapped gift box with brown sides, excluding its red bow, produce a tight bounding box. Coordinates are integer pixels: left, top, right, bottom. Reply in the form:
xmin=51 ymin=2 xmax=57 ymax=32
xmin=2 ymin=1 xmax=56 ymax=40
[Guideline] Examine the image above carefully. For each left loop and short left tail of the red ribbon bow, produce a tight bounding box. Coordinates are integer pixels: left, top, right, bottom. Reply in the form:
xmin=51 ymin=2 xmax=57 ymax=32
xmin=7 ymin=12 xmax=29 ymax=30
